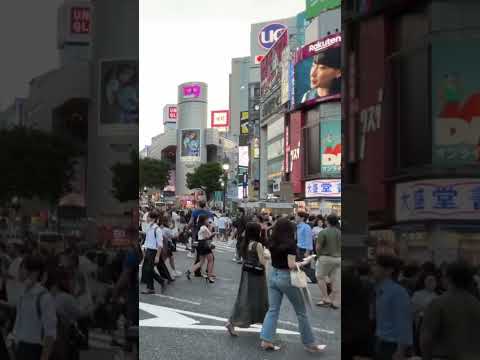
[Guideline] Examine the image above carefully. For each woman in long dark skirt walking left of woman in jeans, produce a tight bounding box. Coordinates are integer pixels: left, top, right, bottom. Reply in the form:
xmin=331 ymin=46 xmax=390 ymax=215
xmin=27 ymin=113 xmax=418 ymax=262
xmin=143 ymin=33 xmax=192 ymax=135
xmin=225 ymin=222 xmax=268 ymax=336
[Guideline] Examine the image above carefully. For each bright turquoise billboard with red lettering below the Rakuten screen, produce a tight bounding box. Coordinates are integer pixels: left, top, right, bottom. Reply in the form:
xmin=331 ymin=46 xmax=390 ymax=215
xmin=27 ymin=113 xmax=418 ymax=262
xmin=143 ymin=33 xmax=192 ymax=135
xmin=320 ymin=118 xmax=342 ymax=178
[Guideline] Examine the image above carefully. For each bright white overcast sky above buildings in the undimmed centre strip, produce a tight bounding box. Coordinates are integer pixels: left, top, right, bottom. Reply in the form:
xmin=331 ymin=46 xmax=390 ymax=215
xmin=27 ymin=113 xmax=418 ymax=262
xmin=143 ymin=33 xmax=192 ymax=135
xmin=139 ymin=0 xmax=305 ymax=148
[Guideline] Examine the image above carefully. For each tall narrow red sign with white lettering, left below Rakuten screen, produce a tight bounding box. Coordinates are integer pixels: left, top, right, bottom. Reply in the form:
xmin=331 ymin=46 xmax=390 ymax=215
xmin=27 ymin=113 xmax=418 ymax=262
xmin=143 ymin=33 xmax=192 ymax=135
xmin=289 ymin=111 xmax=304 ymax=194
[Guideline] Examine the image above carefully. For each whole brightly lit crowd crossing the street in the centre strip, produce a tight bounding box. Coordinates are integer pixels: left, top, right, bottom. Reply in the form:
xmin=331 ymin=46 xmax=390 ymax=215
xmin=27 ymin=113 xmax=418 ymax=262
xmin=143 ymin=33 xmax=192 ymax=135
xmin=140 ymin=202 xmax=341 ymax=352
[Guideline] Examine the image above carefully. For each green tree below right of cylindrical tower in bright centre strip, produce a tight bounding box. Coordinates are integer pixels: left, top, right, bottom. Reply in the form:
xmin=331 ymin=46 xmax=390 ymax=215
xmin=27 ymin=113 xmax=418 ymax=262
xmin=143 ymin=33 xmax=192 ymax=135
xmin=187 ymin=162 xmax=223 ymax=198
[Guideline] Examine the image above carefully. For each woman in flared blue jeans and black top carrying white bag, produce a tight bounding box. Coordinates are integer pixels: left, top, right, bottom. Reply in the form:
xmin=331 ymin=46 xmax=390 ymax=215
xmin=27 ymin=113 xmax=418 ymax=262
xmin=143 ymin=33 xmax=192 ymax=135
xmin=260 ymin=218 xmax=325 ymax=353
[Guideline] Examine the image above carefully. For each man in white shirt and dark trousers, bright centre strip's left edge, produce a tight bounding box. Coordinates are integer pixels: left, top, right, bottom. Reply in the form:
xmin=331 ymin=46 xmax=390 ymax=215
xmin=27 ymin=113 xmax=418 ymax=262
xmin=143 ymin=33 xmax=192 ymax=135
xmin=142 ymin=211 xmax=165 ymax=294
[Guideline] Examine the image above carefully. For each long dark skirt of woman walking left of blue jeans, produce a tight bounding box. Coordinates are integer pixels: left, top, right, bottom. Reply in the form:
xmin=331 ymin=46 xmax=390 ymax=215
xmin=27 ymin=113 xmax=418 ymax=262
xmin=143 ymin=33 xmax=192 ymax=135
xmin=229 ymin=271 xmax=268 ymax=328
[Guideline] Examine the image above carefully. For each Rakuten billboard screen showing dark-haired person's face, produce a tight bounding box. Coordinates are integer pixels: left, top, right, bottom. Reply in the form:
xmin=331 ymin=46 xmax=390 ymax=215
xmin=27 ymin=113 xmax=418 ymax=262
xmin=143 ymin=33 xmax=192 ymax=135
xmin=294 ymin=33 xmax=342 ymax=108
